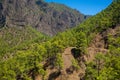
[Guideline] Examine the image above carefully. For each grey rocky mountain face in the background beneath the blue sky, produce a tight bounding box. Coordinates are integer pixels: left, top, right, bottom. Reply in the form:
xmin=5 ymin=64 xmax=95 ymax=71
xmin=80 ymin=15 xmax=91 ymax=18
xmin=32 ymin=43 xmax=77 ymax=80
xmin=0 ymin=0 xmax=86 ymax=36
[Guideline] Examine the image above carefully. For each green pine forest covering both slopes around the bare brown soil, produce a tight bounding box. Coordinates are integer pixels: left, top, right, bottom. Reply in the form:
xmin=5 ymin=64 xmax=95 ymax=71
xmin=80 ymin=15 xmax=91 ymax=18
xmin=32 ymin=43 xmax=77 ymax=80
xmin=0 ymin=0 xmax=120 ymax=80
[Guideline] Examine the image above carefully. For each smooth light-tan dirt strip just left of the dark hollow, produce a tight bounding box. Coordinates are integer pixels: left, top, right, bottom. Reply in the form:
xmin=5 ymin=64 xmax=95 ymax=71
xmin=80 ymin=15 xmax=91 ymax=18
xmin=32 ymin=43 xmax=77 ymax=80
xmin=56 ymin=47 xmax=80 ymax=80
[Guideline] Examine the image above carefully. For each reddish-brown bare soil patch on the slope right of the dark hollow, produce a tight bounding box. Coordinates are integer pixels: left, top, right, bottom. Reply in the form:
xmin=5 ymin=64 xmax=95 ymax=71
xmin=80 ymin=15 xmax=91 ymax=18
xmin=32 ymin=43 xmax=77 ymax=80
xmin=84 ymin=34 xmax=108 ymax=62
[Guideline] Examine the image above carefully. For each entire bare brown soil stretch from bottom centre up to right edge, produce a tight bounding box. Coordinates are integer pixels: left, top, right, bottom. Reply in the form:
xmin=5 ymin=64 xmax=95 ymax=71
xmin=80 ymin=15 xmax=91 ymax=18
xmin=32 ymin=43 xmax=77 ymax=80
xmin=36 ymin=26 xmax=120 ymax=80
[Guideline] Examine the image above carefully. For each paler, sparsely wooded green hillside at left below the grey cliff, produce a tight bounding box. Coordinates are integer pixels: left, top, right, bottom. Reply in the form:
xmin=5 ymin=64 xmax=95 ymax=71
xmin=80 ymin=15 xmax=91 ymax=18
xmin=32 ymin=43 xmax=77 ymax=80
xmin=0 ymin=27 xmax=47 ymax=59
